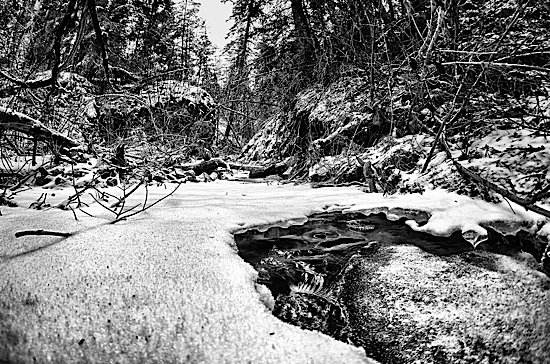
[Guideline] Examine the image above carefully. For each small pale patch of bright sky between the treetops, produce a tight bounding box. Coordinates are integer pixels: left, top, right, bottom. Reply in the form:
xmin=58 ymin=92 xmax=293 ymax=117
xmin=199 ymin=0 xmax=233 ymax=50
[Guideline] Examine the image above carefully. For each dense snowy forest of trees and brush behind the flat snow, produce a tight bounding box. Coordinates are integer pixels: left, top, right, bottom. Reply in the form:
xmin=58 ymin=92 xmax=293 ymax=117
xmin=0 ymin=0 xmax=550 ymax=210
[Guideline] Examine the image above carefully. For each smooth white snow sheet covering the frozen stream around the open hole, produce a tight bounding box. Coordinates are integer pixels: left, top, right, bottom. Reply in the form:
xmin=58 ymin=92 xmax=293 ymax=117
xmin=0 ymin=181 xmax=548 ymax=363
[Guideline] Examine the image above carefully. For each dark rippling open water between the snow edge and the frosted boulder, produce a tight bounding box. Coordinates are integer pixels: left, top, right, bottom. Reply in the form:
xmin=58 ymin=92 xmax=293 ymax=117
xmin=235 ymin=212 xmax=473 ymax=342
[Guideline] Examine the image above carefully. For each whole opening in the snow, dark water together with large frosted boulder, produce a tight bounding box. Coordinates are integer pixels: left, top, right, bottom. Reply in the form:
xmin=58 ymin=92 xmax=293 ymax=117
xmin=235 ymin=212 xmax=550 ymax=363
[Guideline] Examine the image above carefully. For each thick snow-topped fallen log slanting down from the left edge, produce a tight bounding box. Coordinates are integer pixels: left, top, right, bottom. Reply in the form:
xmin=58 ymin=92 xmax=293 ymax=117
xmin=0 ymin=107 xmax=80 ymax=148
